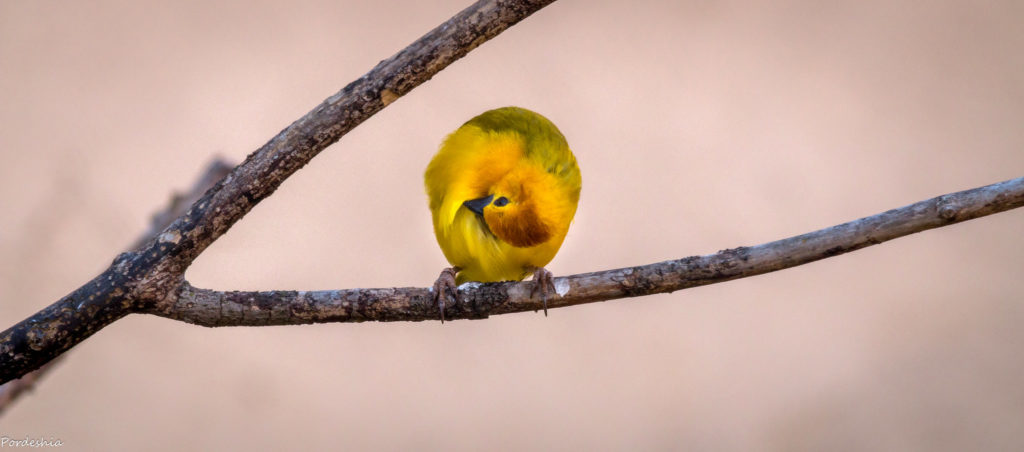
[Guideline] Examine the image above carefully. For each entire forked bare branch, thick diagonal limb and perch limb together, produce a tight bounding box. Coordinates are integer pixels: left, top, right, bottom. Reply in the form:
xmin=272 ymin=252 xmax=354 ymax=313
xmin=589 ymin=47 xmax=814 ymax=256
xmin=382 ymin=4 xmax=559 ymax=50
xmin=0 ymin=0 xmax=1024 ymax=405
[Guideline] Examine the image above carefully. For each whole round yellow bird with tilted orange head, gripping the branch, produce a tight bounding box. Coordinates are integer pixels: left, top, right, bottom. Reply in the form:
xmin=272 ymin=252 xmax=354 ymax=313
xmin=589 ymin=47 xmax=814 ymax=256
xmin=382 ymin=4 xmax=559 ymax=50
xmin=424 ymin=107 xmax=583 ymax=321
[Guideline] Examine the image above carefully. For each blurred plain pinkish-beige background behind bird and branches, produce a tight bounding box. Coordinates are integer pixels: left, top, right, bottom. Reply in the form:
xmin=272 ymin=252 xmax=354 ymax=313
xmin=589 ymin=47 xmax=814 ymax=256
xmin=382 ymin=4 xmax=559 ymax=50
xmin=0 ymin=0 xmax=1024 ymax=451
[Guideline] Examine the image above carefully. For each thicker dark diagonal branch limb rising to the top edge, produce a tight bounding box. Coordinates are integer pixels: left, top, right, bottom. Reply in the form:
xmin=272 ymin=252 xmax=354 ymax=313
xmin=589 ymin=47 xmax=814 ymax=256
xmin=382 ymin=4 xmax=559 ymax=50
xmin=0 ymin=0 xmax=554 ymax=383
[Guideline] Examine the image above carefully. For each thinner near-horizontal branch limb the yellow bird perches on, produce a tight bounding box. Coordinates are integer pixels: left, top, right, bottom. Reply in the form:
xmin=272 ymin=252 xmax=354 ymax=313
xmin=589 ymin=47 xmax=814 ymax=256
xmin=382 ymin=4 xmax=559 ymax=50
xmin=146 ymin=177 xmax=1024 ymax=327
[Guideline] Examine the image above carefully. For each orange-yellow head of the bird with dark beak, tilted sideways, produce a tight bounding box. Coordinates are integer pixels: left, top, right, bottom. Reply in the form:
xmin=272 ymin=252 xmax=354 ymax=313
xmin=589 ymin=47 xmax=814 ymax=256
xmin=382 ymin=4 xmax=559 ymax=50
xmin=464 ymin=170 xmax=561 ymax=248
